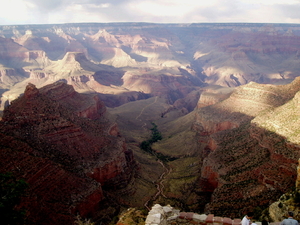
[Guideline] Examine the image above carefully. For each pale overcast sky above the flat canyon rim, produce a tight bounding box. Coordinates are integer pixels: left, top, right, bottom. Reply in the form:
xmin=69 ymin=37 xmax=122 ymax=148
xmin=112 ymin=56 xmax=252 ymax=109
xmin=0 ymin=0 xmax=300 ymax=25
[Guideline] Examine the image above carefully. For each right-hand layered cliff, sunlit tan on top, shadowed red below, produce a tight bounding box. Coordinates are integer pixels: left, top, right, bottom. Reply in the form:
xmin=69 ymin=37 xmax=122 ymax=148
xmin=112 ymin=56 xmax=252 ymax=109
xmin=194 ymin=79 xmax=300 ymax=217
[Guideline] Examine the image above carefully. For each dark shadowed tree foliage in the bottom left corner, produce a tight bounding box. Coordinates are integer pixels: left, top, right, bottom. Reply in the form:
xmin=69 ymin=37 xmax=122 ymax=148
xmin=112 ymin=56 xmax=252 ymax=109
xmin=0 ymin=173 xmax=28 ymax=224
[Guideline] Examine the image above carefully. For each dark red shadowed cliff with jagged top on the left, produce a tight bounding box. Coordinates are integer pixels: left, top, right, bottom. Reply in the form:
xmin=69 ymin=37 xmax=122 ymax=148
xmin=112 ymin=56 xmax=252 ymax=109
xmin=0 ymin=82 xmax=135 ymax=224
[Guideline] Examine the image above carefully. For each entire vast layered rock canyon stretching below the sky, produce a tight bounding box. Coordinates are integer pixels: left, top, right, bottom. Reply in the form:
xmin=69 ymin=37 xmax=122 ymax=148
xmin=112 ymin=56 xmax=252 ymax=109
xmin=0 ymin=23 xmax=300 ymax=224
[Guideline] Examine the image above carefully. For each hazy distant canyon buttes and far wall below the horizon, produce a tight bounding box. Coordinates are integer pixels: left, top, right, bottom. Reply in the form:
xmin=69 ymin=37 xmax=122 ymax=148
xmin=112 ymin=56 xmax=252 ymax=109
xmin=0 ymin=23 xmax=300 ymax=109
